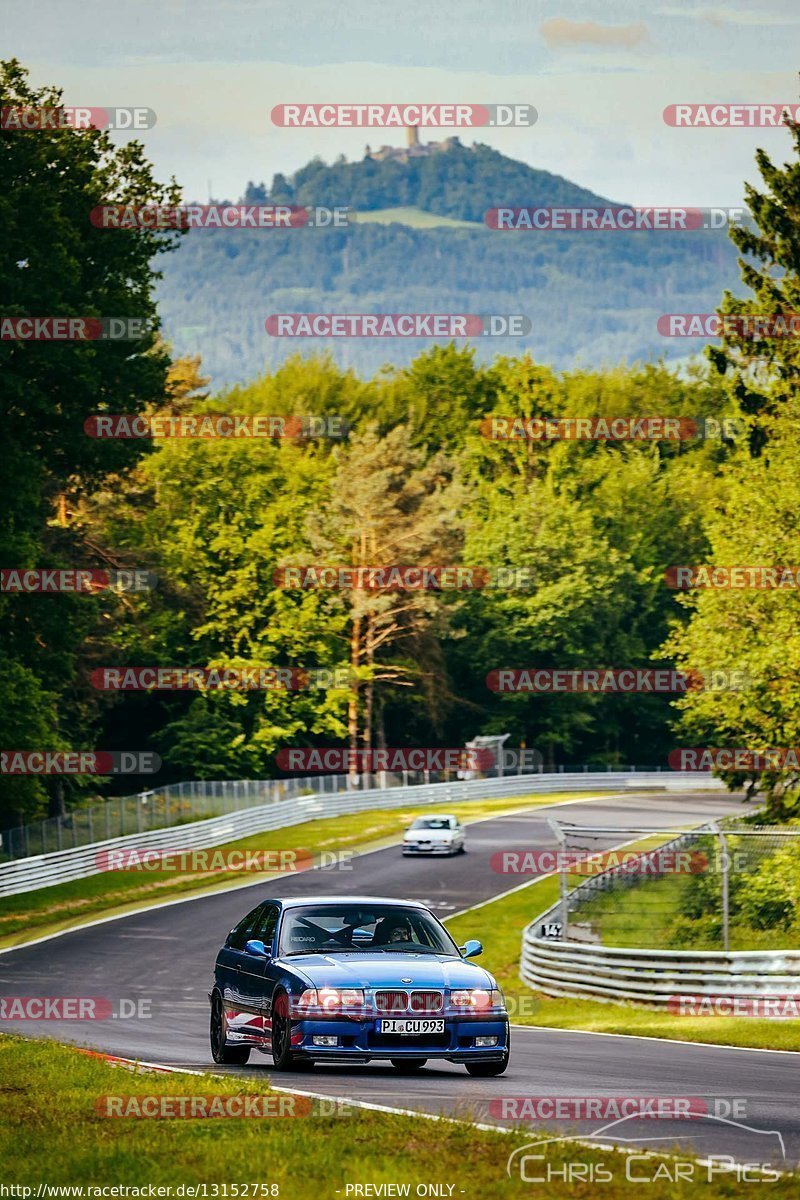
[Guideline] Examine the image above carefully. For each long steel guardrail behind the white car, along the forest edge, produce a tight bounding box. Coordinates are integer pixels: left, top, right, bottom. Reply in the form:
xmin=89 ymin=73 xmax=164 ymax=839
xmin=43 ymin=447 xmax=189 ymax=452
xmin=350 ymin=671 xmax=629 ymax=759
xmin=0 ymin=772 xmax=722 ymax=896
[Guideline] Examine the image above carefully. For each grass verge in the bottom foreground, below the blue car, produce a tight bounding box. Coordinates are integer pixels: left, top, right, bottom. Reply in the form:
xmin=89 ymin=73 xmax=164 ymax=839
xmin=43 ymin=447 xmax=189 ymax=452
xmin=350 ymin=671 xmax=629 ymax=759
xmin=0 ymin=1036 xmax=796 ymax=1200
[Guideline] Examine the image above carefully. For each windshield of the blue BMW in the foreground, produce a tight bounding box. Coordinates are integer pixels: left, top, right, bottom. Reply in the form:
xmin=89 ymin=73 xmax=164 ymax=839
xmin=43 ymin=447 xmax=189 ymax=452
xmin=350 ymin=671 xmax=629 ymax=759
xmin=278 ymin=904 xmax=458 ymax=956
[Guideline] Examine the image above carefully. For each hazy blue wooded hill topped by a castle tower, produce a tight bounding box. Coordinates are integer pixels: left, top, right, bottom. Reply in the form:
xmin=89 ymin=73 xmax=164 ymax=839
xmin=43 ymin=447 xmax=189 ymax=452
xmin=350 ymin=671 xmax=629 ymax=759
xmin=158 ymin=131 xmax=739 ymax=386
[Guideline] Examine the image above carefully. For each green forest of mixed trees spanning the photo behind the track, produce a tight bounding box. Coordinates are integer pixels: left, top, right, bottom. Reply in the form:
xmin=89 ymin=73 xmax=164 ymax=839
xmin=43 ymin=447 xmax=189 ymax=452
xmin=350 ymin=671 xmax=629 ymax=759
xmin=0 ymin=62 xmax=800 ymax=827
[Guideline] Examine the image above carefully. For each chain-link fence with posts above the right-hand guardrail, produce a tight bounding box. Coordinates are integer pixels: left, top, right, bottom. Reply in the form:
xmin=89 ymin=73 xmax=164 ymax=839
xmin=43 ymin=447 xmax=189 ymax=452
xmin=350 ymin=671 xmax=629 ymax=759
xmin=551 ymin=817 xmax=800 ymax=950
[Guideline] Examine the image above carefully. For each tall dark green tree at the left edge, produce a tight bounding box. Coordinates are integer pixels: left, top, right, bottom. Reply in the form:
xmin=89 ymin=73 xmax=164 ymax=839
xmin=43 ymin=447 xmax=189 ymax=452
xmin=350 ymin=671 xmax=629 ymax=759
xmin=0 ymin=60 xmax=178 ymax=822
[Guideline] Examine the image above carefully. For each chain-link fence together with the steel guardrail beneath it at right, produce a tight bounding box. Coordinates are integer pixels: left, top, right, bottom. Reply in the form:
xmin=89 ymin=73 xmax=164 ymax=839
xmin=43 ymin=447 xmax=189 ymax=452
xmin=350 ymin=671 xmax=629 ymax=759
xmin=519 ymin=817 xmax=800 ymax=1016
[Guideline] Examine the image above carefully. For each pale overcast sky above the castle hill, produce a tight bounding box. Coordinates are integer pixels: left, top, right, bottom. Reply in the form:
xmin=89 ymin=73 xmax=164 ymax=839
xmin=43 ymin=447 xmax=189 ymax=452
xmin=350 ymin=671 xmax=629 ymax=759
xmin=6 ymin=0 xmax=800 ymax=205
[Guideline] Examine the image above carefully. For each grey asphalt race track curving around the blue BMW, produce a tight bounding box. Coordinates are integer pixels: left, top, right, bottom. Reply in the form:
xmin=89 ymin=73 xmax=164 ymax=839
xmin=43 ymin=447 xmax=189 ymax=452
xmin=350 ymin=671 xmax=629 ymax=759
xmin=0 ymin=792 xmax=800 ymax=1169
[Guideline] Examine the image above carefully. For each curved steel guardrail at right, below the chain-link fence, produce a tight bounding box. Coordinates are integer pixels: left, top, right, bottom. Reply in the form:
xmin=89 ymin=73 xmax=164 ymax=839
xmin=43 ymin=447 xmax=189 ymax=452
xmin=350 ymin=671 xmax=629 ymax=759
xmin=519 ymin=904 xmax=800 ymax=1008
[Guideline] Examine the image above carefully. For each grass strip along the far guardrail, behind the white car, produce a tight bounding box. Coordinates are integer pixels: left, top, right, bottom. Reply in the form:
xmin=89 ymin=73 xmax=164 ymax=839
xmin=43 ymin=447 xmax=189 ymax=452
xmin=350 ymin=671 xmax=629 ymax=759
xmin=0 ymin=792 xmax=589 ymax=948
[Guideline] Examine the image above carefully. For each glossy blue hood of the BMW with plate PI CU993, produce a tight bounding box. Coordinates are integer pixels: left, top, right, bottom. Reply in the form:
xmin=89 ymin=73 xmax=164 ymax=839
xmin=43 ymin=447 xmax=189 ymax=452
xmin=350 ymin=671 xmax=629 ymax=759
xmin=281 ymin=953 xmax=497 ymax=989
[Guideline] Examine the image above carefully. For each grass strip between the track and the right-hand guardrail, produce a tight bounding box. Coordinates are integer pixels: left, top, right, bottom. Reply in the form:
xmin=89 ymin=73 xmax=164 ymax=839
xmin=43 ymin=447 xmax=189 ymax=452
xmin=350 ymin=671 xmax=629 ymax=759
xmin=446 ymin=876 xmax=800 ymax=1050
